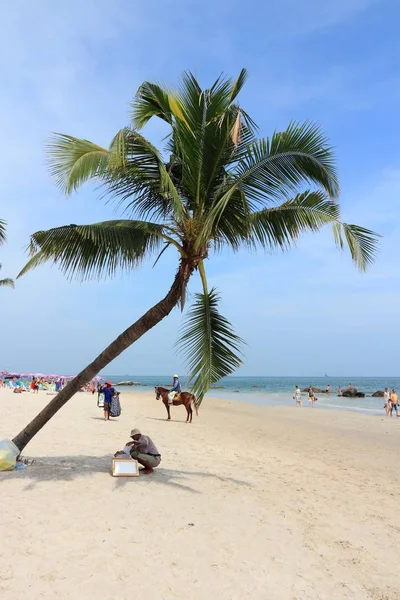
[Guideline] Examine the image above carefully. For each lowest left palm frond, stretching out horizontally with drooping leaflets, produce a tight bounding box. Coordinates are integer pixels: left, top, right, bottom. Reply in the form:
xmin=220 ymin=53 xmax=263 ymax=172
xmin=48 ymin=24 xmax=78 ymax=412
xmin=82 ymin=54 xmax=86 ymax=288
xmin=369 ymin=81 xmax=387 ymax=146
xmin=18 ymin=220 xmax=165 ymax=281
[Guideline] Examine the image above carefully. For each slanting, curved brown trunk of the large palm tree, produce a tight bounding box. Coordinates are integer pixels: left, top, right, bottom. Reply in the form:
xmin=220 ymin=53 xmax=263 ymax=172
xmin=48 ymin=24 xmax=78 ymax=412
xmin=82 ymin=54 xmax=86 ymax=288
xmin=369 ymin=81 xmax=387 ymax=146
xmin=13 ymin=260 xmax=195 ymax=452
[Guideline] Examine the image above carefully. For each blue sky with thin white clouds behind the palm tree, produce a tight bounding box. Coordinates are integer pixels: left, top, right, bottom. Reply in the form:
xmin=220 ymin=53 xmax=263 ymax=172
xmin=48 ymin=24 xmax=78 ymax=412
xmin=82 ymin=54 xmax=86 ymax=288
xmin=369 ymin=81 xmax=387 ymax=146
xmin=0 ymin=0 xmax=400 ymax=375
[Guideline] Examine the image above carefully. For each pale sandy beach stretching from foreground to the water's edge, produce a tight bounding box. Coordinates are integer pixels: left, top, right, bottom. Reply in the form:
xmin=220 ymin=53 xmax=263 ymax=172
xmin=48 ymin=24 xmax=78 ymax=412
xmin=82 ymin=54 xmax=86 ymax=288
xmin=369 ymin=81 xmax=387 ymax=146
xmin=0 ymin=390 xmax=400 ymax=600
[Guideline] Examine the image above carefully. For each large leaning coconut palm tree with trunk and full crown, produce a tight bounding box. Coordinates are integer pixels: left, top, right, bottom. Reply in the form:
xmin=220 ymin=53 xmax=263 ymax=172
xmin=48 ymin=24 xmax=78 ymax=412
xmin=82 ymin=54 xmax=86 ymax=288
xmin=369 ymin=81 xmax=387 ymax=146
xmin=14 ymin=69 xmax=376 ymax=450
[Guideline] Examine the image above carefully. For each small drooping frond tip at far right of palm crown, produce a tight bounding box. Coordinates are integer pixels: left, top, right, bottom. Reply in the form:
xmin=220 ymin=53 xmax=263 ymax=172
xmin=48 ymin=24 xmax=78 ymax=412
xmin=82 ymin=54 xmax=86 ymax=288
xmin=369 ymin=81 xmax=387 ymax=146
xmin=333 ymin=223 xmax=380 ymax=271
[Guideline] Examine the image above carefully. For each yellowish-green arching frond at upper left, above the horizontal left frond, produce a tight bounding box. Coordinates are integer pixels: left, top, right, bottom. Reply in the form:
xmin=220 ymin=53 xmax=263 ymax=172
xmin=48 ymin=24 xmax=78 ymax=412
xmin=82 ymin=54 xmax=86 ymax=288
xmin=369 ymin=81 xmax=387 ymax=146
xmin=47 ymin=127 xmax=184 ymax=219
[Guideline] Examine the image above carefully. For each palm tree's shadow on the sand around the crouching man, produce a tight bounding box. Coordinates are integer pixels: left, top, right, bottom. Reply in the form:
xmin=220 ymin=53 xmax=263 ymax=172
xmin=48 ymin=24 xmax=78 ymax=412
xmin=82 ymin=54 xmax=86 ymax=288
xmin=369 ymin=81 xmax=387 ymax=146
xmin=0 ymin=454 xmax=252 ymax=494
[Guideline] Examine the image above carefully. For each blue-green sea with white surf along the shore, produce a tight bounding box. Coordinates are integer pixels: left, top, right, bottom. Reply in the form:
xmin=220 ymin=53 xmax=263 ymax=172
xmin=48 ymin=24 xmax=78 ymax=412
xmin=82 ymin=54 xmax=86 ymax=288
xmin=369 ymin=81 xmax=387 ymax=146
xmin=104 ymin=375 xmax=400 ymax=415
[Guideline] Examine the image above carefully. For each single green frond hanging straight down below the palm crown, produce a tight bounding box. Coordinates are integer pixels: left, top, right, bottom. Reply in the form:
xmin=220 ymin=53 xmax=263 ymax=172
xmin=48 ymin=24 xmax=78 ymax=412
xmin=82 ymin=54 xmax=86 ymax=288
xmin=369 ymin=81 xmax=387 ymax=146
xmin=178 ymin=289 xmax=243 ymax=405
